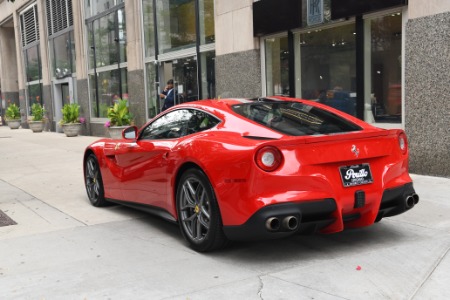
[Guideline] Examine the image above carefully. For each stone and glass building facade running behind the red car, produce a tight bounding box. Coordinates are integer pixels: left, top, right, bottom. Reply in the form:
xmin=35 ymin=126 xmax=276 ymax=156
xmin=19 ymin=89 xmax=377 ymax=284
xmin=0 ymin=0 xmax=450 ymax=177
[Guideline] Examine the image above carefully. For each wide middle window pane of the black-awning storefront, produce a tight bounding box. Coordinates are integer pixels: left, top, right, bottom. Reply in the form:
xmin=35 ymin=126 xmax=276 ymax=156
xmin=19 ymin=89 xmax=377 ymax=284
xmin=300 ymin=24 xmax=356 ymax=115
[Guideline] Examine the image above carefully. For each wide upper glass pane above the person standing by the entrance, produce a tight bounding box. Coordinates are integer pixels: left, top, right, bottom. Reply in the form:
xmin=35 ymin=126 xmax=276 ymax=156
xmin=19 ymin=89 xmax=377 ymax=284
xmin=156 ymin=0 xmax=196 ymax=53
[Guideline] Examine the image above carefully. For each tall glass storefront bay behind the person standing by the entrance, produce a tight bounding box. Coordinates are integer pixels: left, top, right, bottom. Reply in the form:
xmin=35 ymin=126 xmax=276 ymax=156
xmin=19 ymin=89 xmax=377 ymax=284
xmin=142 ymin=0 xmax=215 ymax=118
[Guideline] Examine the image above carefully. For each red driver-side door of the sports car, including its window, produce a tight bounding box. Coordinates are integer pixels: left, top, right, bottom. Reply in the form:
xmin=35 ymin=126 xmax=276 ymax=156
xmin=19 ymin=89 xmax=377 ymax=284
xmin=110 ymin=109 xmax=192 ymax=209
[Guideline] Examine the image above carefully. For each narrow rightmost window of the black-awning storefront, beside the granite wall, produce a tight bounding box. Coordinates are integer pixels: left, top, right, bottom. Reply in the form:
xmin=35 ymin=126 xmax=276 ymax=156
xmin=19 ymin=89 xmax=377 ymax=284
xmin=366 ymin=13 xmax=402 ymax=122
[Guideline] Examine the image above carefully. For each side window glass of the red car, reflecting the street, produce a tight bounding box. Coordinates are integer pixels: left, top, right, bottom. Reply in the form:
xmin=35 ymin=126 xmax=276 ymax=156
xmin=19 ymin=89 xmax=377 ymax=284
xmin=140 ymin=109 xmax=220 ymax=140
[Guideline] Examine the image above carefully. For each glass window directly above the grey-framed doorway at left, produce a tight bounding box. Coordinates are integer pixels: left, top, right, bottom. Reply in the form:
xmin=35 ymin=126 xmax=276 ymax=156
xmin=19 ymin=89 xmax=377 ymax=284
xmin=51 ymin=31 xmax=76 ymax=78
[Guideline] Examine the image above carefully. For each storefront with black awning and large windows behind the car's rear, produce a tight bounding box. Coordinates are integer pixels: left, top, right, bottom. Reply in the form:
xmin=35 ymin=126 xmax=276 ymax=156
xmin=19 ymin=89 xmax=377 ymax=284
xmin=253 ymin=0 xmax=406 ymax=126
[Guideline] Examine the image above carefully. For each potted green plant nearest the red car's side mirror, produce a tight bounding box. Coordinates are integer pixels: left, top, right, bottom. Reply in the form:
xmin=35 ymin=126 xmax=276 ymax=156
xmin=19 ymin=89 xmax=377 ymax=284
xmin=105 ymin=99 xmax=132 ymax=139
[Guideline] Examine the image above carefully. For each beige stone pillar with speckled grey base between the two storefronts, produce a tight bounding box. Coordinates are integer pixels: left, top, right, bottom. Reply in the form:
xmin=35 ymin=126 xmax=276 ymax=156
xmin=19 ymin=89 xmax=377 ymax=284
xmin=214 ymin=0 xmax=262 ymax=98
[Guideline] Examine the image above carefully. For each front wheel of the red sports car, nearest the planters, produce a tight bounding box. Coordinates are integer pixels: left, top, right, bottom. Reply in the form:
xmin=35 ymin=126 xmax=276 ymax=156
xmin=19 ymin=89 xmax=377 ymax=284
xmin=84 ymin=154 xmax=109 ymax=207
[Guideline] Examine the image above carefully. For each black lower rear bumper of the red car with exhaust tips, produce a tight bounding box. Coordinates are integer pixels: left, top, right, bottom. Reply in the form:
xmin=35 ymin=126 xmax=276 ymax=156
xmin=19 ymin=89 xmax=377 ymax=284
xmin=223 ymin=183 xmax=419 ymax=241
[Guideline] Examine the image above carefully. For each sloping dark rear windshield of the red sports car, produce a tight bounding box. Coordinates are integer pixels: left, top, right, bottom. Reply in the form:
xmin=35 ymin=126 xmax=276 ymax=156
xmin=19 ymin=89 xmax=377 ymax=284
xmin=232 ymin=101 xmax=361 ymax=136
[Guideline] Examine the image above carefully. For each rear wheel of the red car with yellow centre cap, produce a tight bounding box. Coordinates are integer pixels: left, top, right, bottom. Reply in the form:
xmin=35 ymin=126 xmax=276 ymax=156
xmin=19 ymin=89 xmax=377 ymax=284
xmin=176 ymin=169 xmax=228 ymax=252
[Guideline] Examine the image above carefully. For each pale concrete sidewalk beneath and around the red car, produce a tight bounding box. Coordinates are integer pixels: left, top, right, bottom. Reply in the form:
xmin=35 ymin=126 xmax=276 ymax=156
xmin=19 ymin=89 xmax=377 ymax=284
xmin=0 ymin=126 xmax=450 ymax=299
